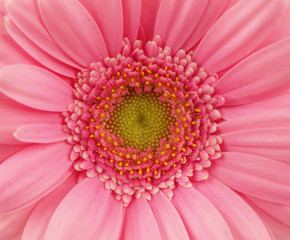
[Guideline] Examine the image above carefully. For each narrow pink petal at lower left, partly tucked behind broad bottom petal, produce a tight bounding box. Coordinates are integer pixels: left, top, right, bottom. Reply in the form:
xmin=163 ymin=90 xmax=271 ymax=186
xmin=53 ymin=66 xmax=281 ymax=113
xmin=21 ymin=174 xmax=77 ymax=240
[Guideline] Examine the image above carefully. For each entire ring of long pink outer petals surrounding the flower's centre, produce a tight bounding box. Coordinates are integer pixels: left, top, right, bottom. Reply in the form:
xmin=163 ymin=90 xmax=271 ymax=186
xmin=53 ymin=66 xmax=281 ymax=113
xmin=0 ymin=0 xmax=290 ymax=240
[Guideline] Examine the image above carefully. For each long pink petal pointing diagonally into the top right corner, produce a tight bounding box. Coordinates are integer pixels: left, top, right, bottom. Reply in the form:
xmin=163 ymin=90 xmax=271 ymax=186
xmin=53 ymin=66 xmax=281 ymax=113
xmin=195 ymin=0 xmax=285 ymax=73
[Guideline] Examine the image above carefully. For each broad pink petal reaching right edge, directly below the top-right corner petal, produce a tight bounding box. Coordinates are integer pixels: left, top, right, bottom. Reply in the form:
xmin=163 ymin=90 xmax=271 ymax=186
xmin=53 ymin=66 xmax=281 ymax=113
xmin=215 ymin=39 xmax=290 ymax=105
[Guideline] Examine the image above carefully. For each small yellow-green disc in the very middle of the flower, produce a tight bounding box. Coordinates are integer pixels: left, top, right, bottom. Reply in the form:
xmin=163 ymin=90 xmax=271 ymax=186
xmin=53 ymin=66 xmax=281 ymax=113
xmin=107 ymin=89 xmax=174 ymax=152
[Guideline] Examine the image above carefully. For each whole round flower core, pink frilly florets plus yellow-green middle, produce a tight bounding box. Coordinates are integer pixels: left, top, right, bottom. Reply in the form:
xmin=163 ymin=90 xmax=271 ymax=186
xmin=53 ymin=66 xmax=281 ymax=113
xmin=63 ymin=36 xmax=224 ymax=206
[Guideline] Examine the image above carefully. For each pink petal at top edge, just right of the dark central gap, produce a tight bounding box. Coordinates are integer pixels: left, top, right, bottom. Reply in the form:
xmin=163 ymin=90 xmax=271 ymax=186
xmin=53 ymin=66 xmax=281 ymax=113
xmin=154 ymin=0 xmax=207 ymax=52
